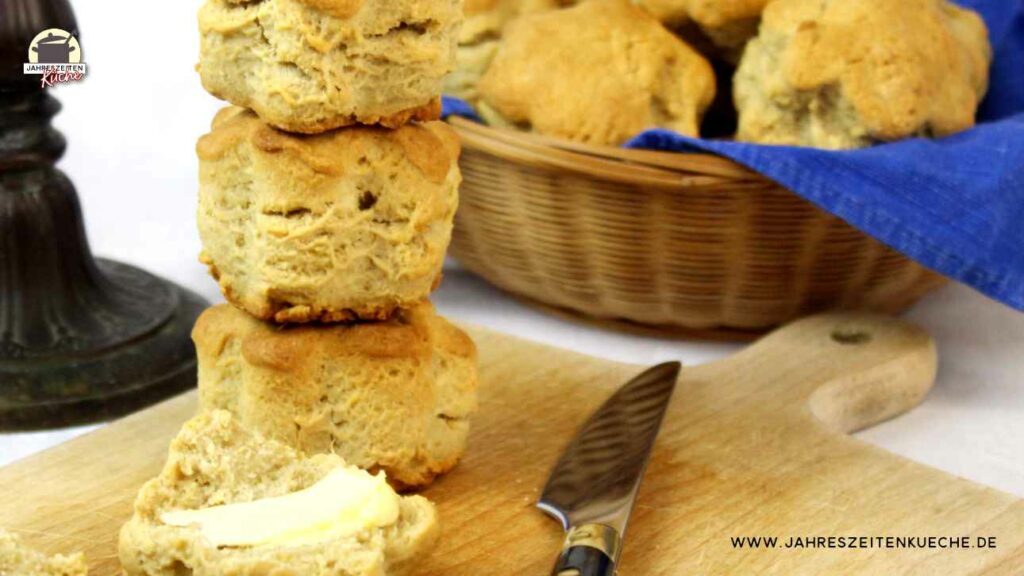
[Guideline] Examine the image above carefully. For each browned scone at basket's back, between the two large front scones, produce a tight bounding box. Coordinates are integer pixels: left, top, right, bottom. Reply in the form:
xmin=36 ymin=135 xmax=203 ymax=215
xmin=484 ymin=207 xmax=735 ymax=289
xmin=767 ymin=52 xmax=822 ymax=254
xmin=636 ymin=0 xmax=770 ymax=56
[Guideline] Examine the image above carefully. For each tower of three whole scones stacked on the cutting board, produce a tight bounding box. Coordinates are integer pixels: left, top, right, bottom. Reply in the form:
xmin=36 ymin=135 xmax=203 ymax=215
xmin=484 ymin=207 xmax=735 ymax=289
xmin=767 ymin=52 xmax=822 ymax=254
xmin=195 ymin=0 xmax=476 ymax=487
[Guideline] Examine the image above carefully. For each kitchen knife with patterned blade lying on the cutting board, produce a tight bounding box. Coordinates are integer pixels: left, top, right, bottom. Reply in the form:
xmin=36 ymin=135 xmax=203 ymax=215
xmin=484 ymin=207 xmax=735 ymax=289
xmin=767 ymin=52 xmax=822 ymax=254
xmin=537 ymin=362 xmax=681 ymax=576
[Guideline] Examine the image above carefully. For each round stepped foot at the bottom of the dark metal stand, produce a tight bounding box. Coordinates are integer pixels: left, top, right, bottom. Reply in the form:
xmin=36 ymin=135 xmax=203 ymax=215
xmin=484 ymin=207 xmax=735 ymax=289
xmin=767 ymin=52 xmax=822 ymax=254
xmin=0 ymin=259 xmax=207 ymax=430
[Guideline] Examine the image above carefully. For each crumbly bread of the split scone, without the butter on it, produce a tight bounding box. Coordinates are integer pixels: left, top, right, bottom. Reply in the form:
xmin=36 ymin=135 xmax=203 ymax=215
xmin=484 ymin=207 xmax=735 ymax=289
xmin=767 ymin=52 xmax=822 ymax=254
xmin=119 ymin=411 xmax=438 ymax=576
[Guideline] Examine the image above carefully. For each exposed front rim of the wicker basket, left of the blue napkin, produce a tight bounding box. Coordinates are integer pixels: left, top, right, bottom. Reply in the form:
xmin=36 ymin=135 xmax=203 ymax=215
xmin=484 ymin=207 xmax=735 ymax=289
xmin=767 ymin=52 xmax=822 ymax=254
xmin=445 ymin=116 xmax=771 ymax=188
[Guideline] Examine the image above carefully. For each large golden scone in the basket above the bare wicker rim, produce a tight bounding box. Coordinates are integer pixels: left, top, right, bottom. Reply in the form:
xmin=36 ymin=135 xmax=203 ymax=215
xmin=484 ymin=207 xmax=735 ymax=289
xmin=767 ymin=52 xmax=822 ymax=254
xmin=479 ymin=0 xmax=715 ymax=145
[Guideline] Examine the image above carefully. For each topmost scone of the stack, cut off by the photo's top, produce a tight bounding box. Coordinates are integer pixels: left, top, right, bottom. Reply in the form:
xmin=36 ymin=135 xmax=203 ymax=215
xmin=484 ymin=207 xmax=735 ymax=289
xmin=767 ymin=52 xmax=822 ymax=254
xmin=199 ymin=0 xmax=462 ymax=133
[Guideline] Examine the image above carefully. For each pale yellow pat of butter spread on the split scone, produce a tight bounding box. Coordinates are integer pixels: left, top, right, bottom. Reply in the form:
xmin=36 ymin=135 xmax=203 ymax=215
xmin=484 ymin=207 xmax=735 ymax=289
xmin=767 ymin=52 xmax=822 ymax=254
xmin=160 ymin=467 xmax=399 ymax=547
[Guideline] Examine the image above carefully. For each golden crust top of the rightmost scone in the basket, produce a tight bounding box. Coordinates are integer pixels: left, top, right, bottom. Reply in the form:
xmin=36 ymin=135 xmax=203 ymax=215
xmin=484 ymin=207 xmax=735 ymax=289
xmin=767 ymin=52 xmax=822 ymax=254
xmin=749 ymin=0 xmax=991 ymax=140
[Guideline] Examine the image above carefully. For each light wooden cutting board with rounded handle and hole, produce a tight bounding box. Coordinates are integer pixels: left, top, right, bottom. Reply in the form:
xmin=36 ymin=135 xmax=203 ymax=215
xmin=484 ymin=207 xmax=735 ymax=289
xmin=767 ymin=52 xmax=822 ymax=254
xmin=0 ymin=315 xmax=1024 ymax=576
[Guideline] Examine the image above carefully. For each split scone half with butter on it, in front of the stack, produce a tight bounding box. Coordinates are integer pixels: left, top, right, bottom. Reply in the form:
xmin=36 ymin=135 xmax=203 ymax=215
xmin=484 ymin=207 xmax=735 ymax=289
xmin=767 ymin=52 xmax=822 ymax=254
xmin=119 ymin=411 xmax=437 ymax=576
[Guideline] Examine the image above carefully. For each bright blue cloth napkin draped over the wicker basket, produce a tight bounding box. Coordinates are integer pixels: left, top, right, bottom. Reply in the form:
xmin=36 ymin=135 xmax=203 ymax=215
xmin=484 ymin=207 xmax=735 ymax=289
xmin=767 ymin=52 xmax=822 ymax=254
xmin=444 ymin=0 xmax=1024 ymax=311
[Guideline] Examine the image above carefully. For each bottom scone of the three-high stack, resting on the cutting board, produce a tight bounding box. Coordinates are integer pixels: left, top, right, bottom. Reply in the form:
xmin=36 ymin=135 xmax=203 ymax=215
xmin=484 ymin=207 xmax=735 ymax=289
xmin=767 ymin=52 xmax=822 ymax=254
xmin=193 ymin=302 xmax=476 ymax=488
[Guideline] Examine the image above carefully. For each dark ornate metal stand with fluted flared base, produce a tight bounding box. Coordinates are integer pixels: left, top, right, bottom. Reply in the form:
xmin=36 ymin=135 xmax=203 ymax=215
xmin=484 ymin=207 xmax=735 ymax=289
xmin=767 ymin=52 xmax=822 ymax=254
xmin=0 ymin=0 xmax=206 ymax=429
